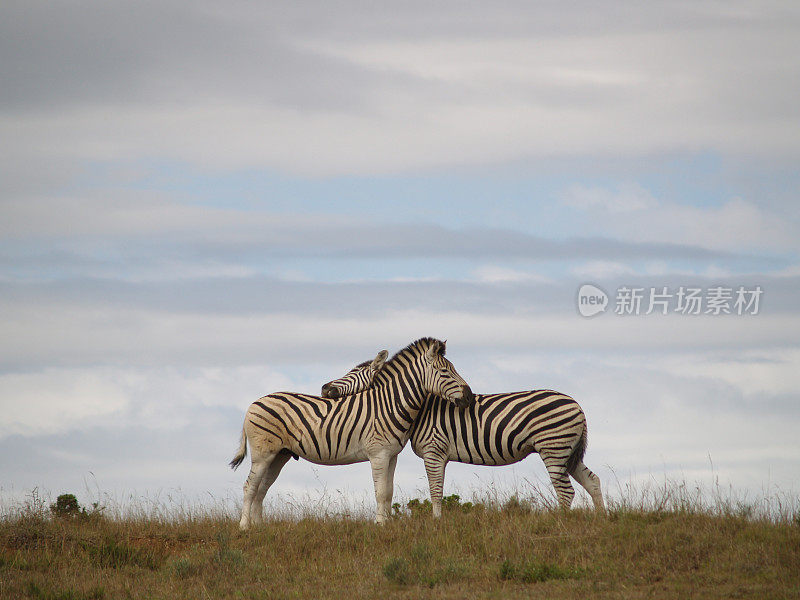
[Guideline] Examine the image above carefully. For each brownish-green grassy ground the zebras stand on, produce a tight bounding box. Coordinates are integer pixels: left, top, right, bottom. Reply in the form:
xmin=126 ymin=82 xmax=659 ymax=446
xmin=0 ymin=486 xmax=800 ymax=600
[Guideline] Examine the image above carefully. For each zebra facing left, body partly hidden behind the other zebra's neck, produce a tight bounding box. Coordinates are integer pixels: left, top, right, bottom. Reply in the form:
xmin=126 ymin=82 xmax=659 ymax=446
xmin=323 ymin=354 xmax=604 ymax=517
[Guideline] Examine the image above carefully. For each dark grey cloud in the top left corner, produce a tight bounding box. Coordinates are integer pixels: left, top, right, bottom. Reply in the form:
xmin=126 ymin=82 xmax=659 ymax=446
xmin=0 ymin=0 xmax=382 ymax=113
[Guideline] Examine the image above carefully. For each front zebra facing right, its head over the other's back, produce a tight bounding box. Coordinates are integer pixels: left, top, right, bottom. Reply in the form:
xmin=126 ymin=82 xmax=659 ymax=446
xmin=230 ymin=338 xmax=474 ymax=530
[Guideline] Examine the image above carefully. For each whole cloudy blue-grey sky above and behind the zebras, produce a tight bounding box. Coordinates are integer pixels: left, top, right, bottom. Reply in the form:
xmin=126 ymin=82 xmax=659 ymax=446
xmin=0 ymin=0 xmax=800 ymax=510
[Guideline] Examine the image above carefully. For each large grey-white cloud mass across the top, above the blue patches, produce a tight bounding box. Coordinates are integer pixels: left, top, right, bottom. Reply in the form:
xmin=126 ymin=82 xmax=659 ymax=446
xmin=0 ymin=2 xmax=800 ymax=175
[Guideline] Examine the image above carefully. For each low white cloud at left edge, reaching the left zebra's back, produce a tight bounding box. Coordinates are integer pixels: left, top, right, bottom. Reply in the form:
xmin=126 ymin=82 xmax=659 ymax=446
xmin=0 ymin=366 xmax=304 ymax=438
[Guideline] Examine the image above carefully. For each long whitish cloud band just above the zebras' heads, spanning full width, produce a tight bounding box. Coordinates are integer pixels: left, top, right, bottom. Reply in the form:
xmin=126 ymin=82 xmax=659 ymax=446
xmin=0 ymin=300 xmax=800 ymax=366
